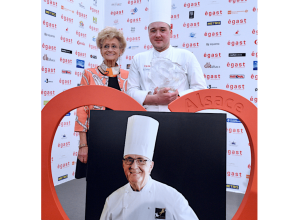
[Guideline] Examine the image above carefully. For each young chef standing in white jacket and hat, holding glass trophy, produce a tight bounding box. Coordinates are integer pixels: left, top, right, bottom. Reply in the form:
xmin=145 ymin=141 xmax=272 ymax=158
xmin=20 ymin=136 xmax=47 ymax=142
xmin=127 ymin=0 xmax=207 ymax=112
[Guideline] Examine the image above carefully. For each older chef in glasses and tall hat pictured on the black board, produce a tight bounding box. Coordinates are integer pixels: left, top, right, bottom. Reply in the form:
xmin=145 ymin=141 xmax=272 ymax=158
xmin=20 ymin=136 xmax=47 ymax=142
xmin=100 ymin=115 xmax=198 ymax=220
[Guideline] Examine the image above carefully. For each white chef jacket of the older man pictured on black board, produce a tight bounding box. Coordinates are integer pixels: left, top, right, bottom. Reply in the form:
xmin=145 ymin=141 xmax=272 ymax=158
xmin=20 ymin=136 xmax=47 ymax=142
xmin=100 ymin=178 xmax=198 ymax=220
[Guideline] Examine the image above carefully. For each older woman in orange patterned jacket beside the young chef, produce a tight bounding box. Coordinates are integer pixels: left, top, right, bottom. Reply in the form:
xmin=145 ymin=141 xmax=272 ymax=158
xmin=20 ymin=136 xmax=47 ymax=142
xmin=74 ymin=27 xmax=128 ymax=178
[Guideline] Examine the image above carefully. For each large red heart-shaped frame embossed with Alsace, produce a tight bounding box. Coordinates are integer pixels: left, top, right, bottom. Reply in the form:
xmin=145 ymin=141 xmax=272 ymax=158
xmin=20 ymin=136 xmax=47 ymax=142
xmin=41 ymin=85 xmax=257 ymax=220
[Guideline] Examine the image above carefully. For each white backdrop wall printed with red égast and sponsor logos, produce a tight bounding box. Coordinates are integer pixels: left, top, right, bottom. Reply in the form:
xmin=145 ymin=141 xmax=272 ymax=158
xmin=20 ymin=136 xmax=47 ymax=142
xmin=41 ymin=0 xmax=258 ymax=193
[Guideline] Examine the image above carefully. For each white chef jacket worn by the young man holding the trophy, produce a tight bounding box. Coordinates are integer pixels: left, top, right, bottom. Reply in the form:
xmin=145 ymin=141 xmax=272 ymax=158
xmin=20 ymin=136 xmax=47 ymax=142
xmin=127 ymin=46 xmax=207 ymax=112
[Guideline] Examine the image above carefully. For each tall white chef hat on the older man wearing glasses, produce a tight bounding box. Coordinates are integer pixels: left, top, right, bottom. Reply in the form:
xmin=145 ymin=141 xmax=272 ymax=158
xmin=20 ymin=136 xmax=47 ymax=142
xmin=123 ymin=115 xmax=159 ymax=160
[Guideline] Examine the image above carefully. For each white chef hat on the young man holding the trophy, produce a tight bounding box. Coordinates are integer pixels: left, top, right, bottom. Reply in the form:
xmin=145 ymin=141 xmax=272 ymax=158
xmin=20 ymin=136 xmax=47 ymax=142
xmin=148 ymin=0 xmax=172 ymax=26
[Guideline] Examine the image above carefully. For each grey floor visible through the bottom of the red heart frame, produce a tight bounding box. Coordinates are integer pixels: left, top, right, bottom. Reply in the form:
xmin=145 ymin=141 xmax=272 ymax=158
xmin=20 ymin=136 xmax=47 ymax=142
xmin=55 ymin=178 xmax=244 ymax=220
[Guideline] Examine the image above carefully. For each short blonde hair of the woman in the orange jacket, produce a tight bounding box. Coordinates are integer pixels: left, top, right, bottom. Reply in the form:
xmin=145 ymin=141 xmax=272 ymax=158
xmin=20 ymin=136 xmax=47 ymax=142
xmin=96 ymin=27 xmax=126 ymax=54
